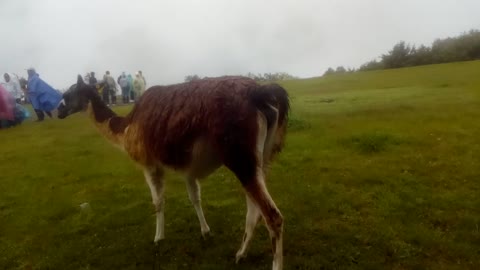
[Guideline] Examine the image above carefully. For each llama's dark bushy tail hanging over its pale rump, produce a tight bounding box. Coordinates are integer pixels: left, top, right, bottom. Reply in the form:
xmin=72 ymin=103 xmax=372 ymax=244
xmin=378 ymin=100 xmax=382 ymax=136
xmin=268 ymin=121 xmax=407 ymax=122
xmin=250 ymin=83 xmax=290 ymax=160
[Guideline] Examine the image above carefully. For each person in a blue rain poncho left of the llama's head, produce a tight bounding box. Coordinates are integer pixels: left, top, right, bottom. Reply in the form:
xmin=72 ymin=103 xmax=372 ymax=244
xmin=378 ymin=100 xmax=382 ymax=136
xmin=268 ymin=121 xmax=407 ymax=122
xmin=27 ymin=68 xmax=62 ymax=122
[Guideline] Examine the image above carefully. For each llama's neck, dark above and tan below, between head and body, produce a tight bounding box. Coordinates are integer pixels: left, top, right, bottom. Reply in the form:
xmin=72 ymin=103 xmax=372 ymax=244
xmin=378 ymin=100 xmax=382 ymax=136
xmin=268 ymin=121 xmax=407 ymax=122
xmin=87 ymin=90 xmax=127 ymax=146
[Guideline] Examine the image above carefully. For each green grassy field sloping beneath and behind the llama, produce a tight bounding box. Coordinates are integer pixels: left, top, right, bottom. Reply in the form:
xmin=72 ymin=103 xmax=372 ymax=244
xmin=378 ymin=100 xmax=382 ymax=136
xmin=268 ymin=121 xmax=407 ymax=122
xmin=0 ymin=62 xmax=480 ymax=269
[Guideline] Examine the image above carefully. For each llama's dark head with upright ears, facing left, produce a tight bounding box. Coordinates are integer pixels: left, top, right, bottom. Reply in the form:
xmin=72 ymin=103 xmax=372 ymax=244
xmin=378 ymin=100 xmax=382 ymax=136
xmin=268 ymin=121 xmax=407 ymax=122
xmin=58 ymin=75 xmax=101 ymax=119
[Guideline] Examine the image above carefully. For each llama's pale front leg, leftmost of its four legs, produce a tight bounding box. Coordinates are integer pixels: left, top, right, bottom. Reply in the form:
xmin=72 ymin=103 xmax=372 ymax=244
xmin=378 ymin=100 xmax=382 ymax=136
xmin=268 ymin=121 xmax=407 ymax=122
xmin=144 ymin=168 xmax=165 ymax=242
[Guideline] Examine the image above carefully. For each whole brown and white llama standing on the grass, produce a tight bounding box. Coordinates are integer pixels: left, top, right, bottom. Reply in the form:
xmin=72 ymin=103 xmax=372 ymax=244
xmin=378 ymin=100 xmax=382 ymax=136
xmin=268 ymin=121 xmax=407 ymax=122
xmin=58 ymin=75 xmax=289 ymax=270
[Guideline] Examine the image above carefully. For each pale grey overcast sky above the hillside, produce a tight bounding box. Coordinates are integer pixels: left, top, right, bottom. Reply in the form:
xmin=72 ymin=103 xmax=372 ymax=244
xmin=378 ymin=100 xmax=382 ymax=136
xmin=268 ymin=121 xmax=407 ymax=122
xmin=0 ymin=0 xmax=480 ymax=89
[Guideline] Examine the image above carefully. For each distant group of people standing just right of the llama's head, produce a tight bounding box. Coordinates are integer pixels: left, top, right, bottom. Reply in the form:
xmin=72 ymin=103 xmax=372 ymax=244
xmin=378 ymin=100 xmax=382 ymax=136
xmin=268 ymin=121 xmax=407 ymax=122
xmin=84 ymin=70 xmax=146 ymax=105
